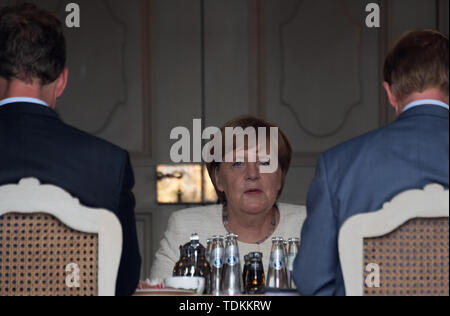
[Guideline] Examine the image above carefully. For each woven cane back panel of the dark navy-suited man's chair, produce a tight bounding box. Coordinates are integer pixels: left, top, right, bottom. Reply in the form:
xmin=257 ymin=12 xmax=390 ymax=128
xmin=0 ymin=213 xmax=98 ymax=296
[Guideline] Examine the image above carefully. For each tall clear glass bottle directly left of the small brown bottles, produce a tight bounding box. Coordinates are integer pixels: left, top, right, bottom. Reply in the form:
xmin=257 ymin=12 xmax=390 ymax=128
xmin=221 ymin=234 xmax=242 ymax=295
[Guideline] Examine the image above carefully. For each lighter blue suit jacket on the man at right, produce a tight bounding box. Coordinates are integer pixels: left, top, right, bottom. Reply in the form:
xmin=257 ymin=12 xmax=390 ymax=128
xmin=294 ymin=105 xmax=449 ymax=295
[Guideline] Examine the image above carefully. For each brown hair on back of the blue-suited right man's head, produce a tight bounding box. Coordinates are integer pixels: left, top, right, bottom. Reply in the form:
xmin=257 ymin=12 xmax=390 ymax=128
xmin=384 ymin=30 xmax=449 ymax=100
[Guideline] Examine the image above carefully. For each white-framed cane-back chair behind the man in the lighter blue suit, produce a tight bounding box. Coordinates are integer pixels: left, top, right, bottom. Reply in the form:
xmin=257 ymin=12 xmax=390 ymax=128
xmin=338 ymin=184 xmax=449 ymax=296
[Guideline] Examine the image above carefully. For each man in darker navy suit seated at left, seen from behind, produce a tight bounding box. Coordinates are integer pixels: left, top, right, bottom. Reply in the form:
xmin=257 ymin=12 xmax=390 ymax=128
xmin=0 ymin=4 xmax=141 ymax=295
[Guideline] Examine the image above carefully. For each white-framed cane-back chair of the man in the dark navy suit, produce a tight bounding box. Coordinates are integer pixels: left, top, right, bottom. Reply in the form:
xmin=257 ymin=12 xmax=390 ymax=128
xmin=0 ymin=178 xmax=122 ymax=296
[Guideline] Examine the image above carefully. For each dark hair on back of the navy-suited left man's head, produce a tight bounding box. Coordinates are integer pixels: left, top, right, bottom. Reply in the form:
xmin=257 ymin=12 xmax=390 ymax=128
xmin=0 ymin=4 xmax=66 ymax=85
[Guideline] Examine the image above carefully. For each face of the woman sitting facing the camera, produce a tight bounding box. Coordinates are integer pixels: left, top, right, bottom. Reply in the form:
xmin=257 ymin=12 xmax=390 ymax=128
xmin=215 ymin=151 xmax=282 ymax=214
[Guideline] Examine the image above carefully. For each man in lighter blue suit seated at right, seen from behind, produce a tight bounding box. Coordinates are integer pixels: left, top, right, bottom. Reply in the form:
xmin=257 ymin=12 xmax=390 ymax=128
xmin=294 ymin=31 xmax=449 ymax=295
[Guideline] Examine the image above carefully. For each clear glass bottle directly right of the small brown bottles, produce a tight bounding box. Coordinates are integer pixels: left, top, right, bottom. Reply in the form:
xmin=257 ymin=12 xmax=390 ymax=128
xmin=267 ymin=237 xmax=289 ymax=289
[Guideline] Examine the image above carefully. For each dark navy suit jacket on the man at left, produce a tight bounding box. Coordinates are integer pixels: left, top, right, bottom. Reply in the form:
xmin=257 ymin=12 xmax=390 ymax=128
xmin=0 ymin=103 xmax=141 ymax=295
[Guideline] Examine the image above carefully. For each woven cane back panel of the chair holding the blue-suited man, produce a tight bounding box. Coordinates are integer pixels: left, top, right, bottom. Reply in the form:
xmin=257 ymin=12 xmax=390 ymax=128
xmin=364 ymin=218 xmax=449 ymax=296
